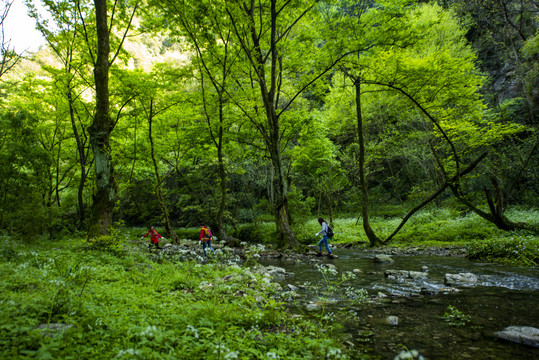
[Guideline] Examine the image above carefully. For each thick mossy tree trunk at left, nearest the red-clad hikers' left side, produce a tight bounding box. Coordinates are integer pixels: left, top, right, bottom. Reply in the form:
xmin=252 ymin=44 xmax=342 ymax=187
xmin=88 ymin=0 xmax=116 ymax=237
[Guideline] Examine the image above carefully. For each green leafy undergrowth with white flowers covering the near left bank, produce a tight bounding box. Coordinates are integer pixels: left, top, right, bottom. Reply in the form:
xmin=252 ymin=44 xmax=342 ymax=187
xmin=0 ymin=233 xmax=347 ymax=359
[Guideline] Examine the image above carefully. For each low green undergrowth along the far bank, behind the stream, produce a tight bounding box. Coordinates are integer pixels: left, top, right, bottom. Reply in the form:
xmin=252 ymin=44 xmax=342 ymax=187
xmin=294 ymin=208 xmax=539 ymax=266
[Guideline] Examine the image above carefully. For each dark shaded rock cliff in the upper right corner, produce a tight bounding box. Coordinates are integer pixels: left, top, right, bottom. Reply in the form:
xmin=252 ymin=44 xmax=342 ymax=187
xmin=456 ymin=0 xmax=539 ymax=125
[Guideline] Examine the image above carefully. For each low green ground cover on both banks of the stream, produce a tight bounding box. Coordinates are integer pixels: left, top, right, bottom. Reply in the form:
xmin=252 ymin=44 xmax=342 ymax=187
xmin=0 ymin=210 xmax=539 ymax=359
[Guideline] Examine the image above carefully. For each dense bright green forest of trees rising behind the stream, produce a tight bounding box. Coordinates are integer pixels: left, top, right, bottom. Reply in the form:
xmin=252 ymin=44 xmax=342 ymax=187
xmin=0 ymin=0 xmax=539 ymax=248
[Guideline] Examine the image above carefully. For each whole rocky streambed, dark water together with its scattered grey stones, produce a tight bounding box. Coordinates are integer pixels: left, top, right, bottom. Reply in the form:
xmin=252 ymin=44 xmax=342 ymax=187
xmin=146 ymin=242 xmax=539 ymax=359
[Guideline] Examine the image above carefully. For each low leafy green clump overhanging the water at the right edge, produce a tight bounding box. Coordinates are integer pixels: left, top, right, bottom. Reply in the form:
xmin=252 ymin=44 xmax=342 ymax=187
xmin=466 ymin=232 xmax=539 ymax=266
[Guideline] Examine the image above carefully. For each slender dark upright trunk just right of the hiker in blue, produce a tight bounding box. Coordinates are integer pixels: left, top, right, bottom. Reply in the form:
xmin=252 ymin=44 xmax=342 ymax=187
xmin=353 ymin=78 xmax=382 ymax=246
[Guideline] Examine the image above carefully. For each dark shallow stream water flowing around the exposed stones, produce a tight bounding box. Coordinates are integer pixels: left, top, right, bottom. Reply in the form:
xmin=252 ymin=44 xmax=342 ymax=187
xmin=260 ymin=249 xmax=539 ymax=359
